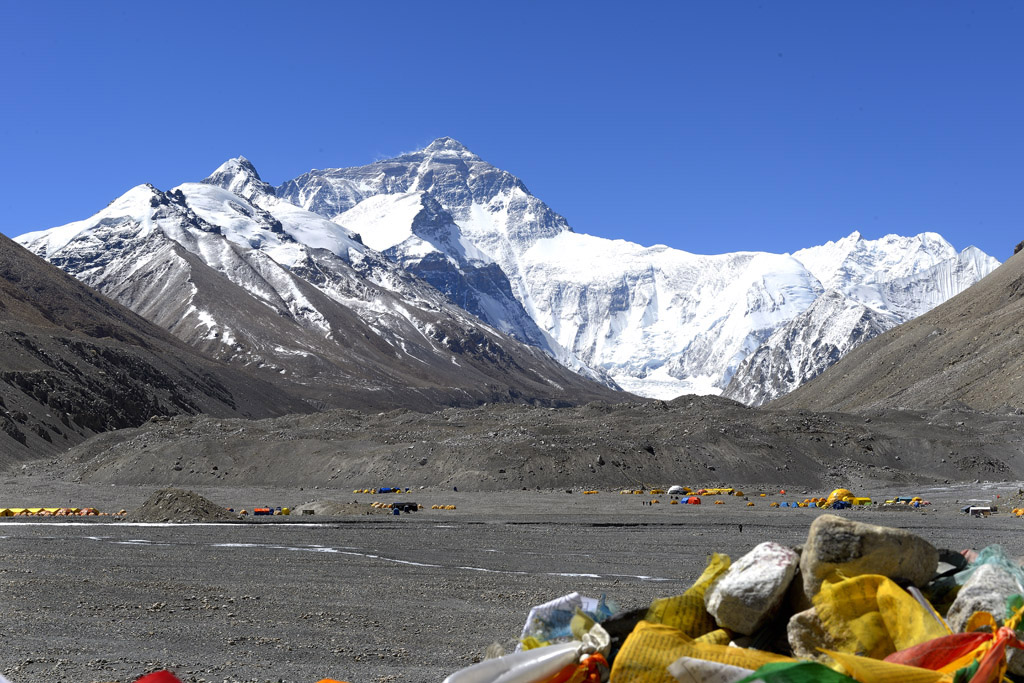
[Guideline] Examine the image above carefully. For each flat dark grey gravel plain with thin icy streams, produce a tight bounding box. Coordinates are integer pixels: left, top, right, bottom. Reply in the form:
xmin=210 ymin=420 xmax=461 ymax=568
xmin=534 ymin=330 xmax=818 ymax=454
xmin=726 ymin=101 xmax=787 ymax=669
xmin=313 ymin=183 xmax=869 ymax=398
xmin=0 ymin=476 xmax=1024 ymax=683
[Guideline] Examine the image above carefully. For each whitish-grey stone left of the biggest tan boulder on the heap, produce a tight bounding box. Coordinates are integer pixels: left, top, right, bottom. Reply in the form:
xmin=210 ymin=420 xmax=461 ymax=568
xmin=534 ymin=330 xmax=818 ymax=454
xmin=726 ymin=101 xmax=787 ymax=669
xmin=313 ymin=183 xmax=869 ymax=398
xmin=705 ymin=541 xmax=800 ymax=635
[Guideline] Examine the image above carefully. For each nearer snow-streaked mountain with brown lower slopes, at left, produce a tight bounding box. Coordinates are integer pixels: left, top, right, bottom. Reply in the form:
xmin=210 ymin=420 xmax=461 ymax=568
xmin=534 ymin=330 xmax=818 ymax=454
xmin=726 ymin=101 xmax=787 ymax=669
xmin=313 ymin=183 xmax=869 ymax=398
xmin=17 ymin=176 xmax=613 ymax=409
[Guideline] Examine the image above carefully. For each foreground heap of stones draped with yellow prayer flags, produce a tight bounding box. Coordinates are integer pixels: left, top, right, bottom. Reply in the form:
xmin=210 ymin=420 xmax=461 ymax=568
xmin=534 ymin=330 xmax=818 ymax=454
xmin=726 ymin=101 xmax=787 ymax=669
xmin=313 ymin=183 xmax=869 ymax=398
xmin=449 ymin=515 xmax=1024 ymax=683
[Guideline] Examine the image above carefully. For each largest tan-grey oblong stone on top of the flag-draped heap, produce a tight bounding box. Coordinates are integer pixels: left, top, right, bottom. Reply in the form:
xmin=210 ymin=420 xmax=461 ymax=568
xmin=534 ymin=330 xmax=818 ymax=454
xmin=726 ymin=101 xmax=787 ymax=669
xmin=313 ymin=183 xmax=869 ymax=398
xmin=800 ymin=515 xmax=939 ymax=598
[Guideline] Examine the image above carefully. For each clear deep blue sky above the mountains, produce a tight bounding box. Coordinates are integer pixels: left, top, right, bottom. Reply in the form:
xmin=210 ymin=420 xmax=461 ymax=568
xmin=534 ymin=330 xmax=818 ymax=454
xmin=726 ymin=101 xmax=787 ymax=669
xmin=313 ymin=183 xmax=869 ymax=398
xmin=0 ymin=0 xmax=1024 ymax=260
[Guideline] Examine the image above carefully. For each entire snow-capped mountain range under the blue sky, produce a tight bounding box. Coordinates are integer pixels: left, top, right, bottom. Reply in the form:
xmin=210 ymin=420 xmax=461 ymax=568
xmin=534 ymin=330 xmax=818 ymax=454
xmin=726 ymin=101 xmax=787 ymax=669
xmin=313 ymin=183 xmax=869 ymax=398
xmin=17 ymin=138 xmax=998 ymax=407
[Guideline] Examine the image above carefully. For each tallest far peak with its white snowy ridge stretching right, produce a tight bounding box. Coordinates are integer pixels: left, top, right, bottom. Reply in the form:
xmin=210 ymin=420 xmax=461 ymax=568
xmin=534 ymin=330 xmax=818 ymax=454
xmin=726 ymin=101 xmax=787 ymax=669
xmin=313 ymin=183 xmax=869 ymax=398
xmin=276 ymin=138 xmax=997 ymax=398
